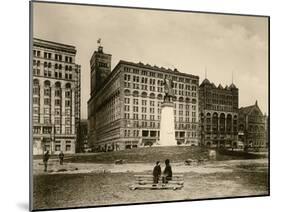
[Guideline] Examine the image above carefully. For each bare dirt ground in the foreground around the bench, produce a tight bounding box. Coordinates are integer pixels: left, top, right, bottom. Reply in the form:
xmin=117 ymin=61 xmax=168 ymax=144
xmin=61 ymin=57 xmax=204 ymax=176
xmin=33 ymin=158 xmax=268 ymax=209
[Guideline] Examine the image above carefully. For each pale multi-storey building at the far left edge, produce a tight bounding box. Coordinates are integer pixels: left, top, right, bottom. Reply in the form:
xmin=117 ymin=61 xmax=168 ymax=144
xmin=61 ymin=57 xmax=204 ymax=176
xmin=32 ymin=38 xmax=81 ymax=155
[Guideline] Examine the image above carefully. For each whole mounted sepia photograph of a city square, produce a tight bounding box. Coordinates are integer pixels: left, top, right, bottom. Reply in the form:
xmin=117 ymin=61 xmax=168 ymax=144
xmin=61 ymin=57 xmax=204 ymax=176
xmin=30 ymin=1 xmax=270 ymax=210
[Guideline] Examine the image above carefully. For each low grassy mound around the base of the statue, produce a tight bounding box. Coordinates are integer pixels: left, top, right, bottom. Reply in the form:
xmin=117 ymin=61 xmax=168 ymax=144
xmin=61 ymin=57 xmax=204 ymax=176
xmin=63 ymin=146 xmax=261 ymax=163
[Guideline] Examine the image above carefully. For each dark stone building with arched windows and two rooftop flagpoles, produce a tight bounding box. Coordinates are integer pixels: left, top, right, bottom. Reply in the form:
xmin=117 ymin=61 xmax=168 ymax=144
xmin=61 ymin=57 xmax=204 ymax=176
xmin=199 ymin=79 xmax=238 ymax=147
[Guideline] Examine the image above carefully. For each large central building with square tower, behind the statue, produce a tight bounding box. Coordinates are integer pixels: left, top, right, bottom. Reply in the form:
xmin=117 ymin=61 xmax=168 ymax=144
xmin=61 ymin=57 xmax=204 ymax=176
xmin=88 ymin=46 xmax=200 ymax=151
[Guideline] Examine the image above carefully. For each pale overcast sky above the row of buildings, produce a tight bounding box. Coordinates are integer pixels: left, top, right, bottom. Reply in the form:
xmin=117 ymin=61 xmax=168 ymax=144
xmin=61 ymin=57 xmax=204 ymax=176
xmin=33 ymin=3 xmax=268 ymax=118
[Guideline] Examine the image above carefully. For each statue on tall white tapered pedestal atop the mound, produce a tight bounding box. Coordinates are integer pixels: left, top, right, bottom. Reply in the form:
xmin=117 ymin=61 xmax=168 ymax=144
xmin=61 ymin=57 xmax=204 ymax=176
xmin=159 ymin=78 xmax=177 ymax=146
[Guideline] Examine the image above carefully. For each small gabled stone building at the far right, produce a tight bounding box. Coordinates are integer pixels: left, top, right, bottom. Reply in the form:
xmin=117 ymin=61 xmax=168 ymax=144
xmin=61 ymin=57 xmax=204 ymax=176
xmin=239 ymin=101 xmax=268 ymax=149
